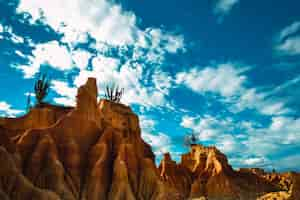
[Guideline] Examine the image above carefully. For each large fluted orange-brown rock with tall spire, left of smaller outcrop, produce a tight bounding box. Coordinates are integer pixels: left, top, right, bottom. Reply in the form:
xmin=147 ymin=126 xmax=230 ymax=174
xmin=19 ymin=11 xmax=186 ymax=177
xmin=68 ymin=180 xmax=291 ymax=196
xmin=0 ymin=79 xmax=174 ymax=200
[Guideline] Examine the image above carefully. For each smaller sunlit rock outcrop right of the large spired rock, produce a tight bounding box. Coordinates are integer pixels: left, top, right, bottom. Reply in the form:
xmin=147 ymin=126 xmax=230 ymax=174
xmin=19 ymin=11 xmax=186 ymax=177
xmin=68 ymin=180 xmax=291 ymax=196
xmin=159 ymin=145 xmax=297 ymax=200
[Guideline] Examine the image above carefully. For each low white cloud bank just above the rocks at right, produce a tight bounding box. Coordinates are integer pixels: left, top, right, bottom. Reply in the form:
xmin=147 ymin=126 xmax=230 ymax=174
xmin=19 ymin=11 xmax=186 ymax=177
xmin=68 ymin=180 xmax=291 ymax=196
xmin=181 ymin=113 xmax=300 ymax=168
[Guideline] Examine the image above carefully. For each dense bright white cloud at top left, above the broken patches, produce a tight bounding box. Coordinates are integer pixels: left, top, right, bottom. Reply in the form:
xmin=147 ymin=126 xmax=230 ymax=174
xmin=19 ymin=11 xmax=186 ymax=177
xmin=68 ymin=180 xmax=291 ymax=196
xmin=18 ymin=0 xmax=183 ymax=53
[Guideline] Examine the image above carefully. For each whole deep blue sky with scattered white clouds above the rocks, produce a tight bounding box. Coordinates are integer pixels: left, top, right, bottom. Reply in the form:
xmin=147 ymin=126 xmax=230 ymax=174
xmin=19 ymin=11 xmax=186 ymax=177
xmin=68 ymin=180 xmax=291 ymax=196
xmin=0 ymin=0 xmax=300 ymax=170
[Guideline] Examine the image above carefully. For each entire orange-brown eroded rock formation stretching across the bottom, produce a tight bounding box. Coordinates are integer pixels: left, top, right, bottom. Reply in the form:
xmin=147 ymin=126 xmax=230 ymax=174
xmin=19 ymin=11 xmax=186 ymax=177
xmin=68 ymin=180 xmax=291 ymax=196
xmin=0 ymin=79 xmax=299 ymax=200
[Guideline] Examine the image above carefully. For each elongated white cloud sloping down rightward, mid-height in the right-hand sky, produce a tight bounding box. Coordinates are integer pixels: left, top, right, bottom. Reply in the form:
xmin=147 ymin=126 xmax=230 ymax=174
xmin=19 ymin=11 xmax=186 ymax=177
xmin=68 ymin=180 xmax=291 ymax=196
xmin=175 ymin=63 xmax=297 ymax=115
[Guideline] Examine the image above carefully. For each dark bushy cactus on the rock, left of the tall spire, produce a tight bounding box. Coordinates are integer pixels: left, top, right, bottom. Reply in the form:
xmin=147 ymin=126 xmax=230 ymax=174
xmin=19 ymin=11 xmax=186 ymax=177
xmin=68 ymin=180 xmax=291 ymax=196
xmin=34 ymin=74 xmax=50 ymax=106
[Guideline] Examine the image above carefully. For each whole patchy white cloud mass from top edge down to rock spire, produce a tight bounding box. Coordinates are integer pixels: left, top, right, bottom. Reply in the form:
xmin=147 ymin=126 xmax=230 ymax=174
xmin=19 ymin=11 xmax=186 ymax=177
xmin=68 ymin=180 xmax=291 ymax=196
xmin=17 ymin=0 xmax=184 ymax=111
